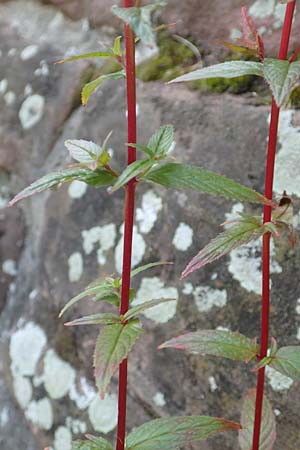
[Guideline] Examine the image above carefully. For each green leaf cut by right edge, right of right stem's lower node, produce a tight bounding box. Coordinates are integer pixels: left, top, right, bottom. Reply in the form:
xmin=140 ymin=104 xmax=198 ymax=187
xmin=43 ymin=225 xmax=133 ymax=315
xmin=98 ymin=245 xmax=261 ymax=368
xmin=270 ymin=345 xmax=300 ymax=381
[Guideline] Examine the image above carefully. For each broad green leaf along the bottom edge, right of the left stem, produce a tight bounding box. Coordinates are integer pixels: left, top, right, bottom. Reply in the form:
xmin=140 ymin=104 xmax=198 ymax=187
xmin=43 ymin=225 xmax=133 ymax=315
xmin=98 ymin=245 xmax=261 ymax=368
xmin=126 ymin=416 xmax=241 ymax=450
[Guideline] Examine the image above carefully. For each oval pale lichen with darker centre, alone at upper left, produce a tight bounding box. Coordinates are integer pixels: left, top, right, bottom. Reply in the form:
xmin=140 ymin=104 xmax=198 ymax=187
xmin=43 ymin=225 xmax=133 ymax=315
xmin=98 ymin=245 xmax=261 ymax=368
xmin=19 ymin=94 xmax=45 ymax=130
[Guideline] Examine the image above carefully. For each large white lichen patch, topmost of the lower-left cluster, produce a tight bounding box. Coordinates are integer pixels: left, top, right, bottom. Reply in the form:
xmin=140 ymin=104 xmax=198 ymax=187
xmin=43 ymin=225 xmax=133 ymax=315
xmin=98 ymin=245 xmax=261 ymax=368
xmin=9 ymin=322 xmax=47 ymax=376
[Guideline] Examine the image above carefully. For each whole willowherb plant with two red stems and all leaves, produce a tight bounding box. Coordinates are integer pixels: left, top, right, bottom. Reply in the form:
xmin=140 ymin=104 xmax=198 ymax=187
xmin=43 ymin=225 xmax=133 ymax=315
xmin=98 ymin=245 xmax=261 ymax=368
xmin=10 ymin=0 xmax=300 ymax=450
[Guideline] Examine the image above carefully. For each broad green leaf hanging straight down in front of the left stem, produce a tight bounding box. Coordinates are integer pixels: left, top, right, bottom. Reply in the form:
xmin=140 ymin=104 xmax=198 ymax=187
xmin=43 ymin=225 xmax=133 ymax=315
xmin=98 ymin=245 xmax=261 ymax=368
xmin=94 ymin=320 xmax=143 ymax=397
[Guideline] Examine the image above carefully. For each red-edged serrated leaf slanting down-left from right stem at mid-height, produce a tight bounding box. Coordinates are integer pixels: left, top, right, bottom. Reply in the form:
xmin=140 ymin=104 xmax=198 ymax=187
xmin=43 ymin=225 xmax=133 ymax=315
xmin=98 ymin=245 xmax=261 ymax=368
xmin=181 ymin=218 xmax=270 ymax=279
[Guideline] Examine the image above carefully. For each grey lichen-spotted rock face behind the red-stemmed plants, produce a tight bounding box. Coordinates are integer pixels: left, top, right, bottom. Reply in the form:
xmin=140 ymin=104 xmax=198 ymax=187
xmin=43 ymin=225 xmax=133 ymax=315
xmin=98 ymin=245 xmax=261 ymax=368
xmin=0 ymin=1 xmax=300 ymax=450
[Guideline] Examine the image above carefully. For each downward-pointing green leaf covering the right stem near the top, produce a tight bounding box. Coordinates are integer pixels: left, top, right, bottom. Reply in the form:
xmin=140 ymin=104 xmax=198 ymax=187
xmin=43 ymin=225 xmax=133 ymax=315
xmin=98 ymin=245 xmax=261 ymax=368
xmin=264 ymin=58 xmax=300 ymax=107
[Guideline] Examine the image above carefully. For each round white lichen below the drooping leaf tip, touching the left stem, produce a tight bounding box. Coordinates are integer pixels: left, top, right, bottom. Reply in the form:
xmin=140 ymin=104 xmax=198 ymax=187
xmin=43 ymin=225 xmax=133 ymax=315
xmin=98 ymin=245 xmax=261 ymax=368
xmin=88 ymin=394 xmax=118 ymax=434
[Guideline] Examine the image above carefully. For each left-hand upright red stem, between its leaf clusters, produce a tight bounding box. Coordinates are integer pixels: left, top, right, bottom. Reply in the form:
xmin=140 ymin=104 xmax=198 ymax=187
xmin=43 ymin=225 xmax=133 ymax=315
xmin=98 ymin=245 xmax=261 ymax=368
xmin=116 ymin=0 xmax=136 ymax=450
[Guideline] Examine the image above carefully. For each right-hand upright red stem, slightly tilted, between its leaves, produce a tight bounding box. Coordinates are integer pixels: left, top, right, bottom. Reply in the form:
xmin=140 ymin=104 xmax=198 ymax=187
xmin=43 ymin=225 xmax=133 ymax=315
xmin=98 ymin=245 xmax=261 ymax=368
xmin=252 ymin=0 xmax=296 ymax=450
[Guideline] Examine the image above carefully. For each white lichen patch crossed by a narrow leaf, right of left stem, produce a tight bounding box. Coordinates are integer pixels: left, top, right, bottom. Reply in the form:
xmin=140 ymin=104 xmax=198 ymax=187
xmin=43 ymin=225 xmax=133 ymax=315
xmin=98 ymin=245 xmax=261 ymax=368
xmin=132 ymin=277 xmax=178 ymax=323
